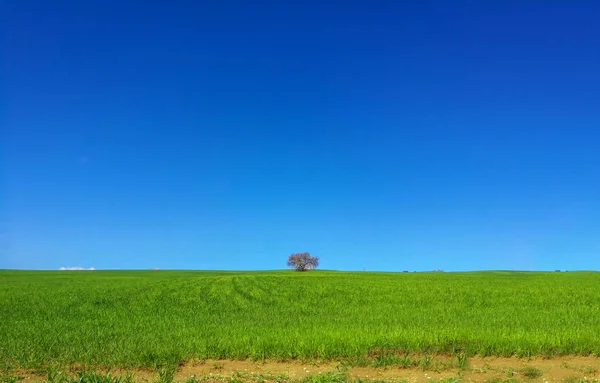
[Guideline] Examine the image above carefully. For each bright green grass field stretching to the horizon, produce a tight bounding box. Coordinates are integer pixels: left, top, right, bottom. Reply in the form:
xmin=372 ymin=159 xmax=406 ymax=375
xmin=0 ymin=270 xmax=600 ymax=368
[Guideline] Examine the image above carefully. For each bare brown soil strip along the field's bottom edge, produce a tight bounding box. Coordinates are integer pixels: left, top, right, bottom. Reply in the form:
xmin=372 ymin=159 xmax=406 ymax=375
xmin=10 ymin=356 xmax=600 ymax=383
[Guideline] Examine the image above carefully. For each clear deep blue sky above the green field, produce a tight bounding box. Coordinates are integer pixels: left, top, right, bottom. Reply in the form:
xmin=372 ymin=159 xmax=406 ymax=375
xmin=0 ymin=0 xmax=600 ymax=271
